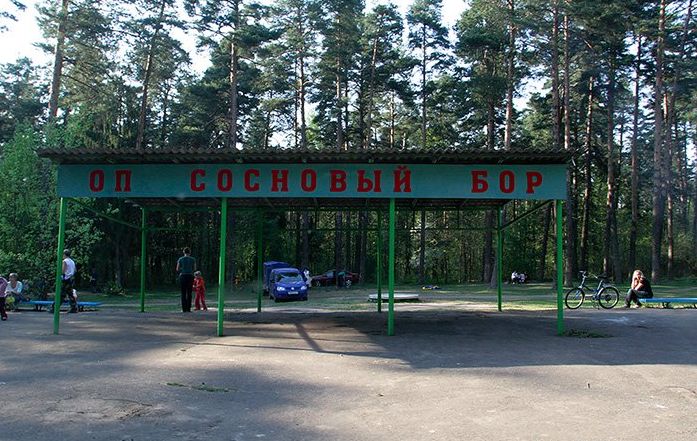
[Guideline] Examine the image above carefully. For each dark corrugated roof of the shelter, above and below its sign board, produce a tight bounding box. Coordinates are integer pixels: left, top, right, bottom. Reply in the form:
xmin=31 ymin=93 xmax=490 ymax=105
xmin=39 ymin=147 xmax=572 ymax=210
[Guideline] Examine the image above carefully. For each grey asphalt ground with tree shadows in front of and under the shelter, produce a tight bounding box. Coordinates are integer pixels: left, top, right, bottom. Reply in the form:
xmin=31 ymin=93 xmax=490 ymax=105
xmin=0 ymin=303 xmax=697 ymax=441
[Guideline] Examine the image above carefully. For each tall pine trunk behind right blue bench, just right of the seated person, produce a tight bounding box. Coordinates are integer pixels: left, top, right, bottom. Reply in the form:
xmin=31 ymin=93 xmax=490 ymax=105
xmin=651 ymin=0 xmax=666 ymax=283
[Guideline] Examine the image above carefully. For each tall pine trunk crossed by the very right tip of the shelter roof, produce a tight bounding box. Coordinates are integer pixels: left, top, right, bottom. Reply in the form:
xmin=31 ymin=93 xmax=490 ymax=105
xmin=563 ymin=9 xmax=577 ymax=286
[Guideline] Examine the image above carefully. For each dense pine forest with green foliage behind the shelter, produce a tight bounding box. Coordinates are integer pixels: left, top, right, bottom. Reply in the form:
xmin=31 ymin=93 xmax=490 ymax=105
xmin=0 ymin=0 xmax=697 ymax=288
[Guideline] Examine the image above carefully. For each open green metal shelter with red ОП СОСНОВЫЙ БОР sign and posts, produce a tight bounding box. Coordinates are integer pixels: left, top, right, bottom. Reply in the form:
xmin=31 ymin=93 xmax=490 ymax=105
xmin=39 ymin=148 xmax=571 ymax=336
